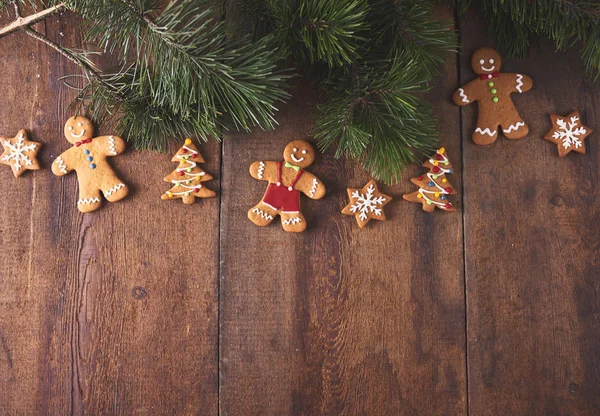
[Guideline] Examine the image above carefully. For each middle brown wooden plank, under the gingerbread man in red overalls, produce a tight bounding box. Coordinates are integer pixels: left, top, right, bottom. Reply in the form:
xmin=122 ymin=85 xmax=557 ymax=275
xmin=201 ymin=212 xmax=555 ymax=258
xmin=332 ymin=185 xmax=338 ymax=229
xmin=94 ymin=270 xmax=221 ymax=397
xmin=220 ymin=8 xmax=466 ymax=415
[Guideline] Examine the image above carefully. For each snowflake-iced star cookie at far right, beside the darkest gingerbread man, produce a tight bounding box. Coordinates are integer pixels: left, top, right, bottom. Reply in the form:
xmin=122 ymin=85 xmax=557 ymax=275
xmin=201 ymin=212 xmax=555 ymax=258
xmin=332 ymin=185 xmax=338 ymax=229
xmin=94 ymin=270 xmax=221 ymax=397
xmin=544 ymin=111 xmax=592 ymax=157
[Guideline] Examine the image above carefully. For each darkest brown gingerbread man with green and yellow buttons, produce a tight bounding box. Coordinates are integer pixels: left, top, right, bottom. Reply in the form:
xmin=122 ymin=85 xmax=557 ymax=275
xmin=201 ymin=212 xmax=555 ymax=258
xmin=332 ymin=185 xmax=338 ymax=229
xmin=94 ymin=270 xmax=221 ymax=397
xmin=452 ymin=48 xmax=533 ymax=145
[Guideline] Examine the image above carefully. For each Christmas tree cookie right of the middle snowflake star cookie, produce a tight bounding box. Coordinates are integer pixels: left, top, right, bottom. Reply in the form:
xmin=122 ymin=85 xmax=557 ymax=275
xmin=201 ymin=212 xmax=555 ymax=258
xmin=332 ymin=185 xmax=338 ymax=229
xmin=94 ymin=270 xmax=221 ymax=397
xmin=402 ymin=147 xmax=456 ymax=212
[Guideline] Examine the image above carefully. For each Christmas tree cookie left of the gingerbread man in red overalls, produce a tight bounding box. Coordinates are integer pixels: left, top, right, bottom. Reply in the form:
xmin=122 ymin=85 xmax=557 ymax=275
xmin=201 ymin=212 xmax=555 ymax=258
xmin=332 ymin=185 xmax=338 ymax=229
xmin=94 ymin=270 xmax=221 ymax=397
xmin=160 ymin=138 xmax=216 ymax=204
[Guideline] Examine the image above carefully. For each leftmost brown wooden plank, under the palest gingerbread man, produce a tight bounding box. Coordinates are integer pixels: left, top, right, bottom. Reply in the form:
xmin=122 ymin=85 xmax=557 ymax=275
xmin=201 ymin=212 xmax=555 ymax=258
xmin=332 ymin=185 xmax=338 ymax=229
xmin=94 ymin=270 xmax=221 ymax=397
xmin=0 ymin=10 xmax=220 ymax=415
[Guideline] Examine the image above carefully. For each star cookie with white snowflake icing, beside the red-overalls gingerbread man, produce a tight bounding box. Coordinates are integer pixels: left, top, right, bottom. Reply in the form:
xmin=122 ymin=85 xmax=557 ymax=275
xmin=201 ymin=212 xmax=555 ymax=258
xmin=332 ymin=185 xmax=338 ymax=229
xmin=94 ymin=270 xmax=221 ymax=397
xmin=342 ymin=179 xmax=392 ymax=228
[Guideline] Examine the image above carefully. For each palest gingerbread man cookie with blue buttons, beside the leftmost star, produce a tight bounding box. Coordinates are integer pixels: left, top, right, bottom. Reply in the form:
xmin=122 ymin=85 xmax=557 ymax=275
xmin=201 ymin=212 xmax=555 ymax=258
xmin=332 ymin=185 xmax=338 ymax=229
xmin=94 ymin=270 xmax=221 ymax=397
xmin=52 ymin=116 xmax=129 ymax=212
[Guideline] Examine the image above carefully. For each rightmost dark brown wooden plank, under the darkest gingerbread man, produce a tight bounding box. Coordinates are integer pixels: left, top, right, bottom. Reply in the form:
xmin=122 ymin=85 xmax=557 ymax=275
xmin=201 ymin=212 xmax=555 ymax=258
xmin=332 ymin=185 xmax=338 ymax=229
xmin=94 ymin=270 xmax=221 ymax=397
xmin=460 ymin=11 xmax=600 ymax=415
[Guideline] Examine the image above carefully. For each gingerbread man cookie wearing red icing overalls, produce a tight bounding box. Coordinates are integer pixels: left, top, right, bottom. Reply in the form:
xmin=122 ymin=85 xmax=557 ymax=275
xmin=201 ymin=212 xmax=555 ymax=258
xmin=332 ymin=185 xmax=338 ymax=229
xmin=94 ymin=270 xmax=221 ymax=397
xmin=248 ymin=140 xmax=325 ymax=232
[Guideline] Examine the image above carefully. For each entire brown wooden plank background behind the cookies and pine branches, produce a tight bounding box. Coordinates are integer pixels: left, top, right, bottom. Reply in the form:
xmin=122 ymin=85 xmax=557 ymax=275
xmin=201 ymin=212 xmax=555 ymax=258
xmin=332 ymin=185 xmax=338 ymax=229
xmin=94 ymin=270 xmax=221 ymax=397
xmin=0 ymin=6 xmax=600 ymax=416
